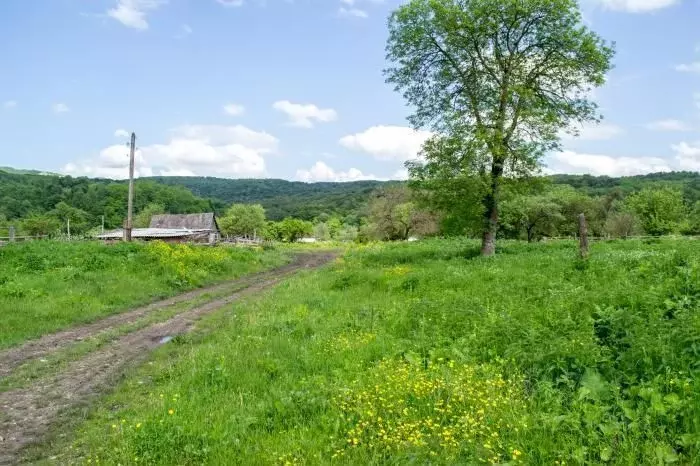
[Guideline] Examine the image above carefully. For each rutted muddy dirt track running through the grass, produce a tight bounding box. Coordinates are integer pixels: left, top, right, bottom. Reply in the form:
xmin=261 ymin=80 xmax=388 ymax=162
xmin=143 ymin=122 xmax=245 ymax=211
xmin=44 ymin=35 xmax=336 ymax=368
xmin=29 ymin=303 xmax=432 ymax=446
xmin=0 ymin=252 xmax=335 ymax=464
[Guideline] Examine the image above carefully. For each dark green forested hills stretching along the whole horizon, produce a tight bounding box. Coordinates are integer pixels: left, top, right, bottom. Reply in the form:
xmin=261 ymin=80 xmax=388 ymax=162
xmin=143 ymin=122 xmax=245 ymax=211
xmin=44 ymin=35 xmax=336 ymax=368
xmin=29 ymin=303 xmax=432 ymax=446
xmin=0 ymin=168 xmax=700 ymax=224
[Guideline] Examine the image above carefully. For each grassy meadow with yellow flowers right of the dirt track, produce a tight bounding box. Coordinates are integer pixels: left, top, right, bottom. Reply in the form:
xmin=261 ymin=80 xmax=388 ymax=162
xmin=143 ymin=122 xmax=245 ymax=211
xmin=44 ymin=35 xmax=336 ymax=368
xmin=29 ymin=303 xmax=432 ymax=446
xmin=43 ymin=240 xmax=700 ymax=465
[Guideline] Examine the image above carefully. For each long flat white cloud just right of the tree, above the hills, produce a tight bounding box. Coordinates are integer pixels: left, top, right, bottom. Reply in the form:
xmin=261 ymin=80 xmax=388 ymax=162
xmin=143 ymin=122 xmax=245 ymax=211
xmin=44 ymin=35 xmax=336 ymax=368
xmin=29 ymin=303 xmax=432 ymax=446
xmin=547 ymin=150 xmax=672 ymax=176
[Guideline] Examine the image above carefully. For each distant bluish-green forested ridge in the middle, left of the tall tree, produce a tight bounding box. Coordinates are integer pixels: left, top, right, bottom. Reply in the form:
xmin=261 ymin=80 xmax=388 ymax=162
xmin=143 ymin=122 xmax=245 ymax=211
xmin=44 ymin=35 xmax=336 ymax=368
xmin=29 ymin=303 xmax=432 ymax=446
xmin=149 ymin=177 xmax=396 ymax=220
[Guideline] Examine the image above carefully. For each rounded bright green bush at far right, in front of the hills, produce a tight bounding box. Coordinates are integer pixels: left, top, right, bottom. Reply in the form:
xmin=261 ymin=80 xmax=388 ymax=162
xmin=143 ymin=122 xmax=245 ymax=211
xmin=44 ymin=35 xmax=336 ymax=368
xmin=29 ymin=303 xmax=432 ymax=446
xmin=626 ymin=188 xmax=686 ymax=235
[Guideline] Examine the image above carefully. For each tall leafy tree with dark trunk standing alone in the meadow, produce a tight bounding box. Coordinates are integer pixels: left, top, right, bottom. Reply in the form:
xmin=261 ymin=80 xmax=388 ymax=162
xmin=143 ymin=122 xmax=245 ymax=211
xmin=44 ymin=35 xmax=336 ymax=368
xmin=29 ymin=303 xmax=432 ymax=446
xmin=386 ymin=0 xmax=614 ymax=255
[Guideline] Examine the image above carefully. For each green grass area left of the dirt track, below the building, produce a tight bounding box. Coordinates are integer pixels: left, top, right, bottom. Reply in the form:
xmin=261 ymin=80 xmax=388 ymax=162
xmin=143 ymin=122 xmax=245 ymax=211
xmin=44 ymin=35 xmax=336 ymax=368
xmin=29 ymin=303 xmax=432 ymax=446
xmin=0 ymin=241 xmax=288 ymax=348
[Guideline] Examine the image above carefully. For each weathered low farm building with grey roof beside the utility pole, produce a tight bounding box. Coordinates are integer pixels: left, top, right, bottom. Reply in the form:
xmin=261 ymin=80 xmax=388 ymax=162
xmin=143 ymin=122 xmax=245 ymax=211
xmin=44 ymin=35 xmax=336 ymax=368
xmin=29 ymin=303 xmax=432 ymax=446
xmin=97 ymin=212 xmax=221 ymax=244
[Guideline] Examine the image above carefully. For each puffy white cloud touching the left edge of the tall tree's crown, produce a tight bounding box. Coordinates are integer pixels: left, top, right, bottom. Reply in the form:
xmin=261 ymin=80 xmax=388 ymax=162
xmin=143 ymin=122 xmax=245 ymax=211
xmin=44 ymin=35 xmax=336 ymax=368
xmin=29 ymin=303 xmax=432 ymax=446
xmin=339 ymin=126 xmax=432 ymax=161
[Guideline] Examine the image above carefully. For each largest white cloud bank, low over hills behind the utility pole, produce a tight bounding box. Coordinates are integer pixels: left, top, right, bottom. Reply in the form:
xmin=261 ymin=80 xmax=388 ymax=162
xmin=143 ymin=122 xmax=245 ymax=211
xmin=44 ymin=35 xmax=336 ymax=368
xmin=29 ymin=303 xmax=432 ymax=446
xmin=63 ymin=125 xmax=279 ymax=179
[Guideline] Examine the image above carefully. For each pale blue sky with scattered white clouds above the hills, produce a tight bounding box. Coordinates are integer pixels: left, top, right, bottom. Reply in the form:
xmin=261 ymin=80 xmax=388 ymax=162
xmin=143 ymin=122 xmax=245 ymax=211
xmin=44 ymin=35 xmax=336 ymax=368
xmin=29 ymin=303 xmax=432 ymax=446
xmin=0 ymin=0 xmax=700 ymax=181
